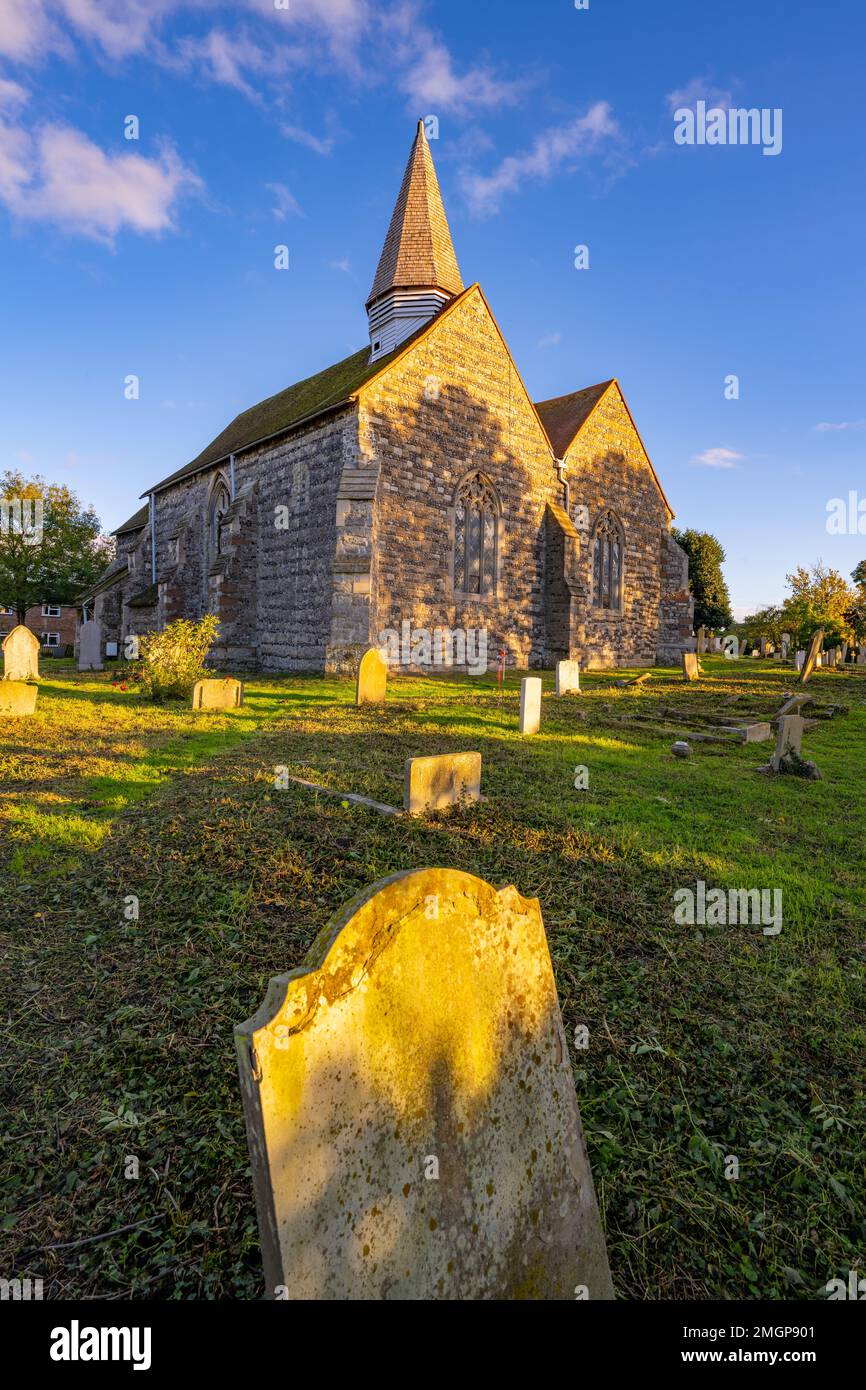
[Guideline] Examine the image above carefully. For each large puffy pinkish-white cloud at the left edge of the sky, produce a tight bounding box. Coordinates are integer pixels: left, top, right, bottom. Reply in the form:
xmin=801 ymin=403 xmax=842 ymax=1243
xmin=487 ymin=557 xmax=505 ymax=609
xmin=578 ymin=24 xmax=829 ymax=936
xmin=0 ymin=122 xmax=202 ymax=245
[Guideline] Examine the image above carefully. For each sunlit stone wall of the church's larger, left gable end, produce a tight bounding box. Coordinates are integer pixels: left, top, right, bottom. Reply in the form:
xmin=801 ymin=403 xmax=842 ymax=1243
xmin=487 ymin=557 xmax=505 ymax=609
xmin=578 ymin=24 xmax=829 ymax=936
xmin=359 ymin=289 xmax=562 ymax=667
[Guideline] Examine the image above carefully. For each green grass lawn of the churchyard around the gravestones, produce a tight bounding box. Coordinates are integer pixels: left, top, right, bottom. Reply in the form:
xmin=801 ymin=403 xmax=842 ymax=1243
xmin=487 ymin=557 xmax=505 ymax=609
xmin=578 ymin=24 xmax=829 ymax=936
xmin=0 ymin=657 xmax=866 ymax=1298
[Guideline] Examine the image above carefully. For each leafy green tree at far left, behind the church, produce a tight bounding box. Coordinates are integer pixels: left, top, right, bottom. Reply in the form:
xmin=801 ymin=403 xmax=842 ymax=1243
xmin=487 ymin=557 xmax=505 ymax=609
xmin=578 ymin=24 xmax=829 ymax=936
xmin=0 ymin=471 xmax=114 ymax=623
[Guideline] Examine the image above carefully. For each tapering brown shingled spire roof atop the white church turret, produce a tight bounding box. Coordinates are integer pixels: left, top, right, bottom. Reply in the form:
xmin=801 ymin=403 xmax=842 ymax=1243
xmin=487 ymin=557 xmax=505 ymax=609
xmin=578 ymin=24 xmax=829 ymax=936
xmin=367 ymin=121 xmax=463 ymax=307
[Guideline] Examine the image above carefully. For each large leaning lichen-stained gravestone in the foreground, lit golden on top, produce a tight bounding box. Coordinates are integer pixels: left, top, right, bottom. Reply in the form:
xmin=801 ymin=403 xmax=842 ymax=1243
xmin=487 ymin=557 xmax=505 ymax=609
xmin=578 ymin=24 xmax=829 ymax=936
xmin=235 ymin=869 xmax=613 ymax=1301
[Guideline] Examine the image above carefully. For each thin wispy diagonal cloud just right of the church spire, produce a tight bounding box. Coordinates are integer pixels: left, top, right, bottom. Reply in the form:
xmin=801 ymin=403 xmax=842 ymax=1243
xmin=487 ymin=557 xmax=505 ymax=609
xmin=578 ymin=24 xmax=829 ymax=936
xmin=461 ymin=101 xmax=620 ymax=217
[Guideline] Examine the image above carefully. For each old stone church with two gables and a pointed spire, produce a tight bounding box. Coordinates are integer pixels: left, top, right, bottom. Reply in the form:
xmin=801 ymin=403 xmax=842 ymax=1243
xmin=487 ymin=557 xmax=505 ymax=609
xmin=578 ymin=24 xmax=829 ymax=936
xmin=90 ymin=122 xmax=694 ymax=673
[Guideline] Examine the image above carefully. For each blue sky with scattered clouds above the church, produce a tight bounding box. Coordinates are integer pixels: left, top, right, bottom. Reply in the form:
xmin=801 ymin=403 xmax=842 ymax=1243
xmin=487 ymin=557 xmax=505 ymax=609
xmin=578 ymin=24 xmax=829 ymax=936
xmin=0 ymin=0 xmax=866 ymax=613
